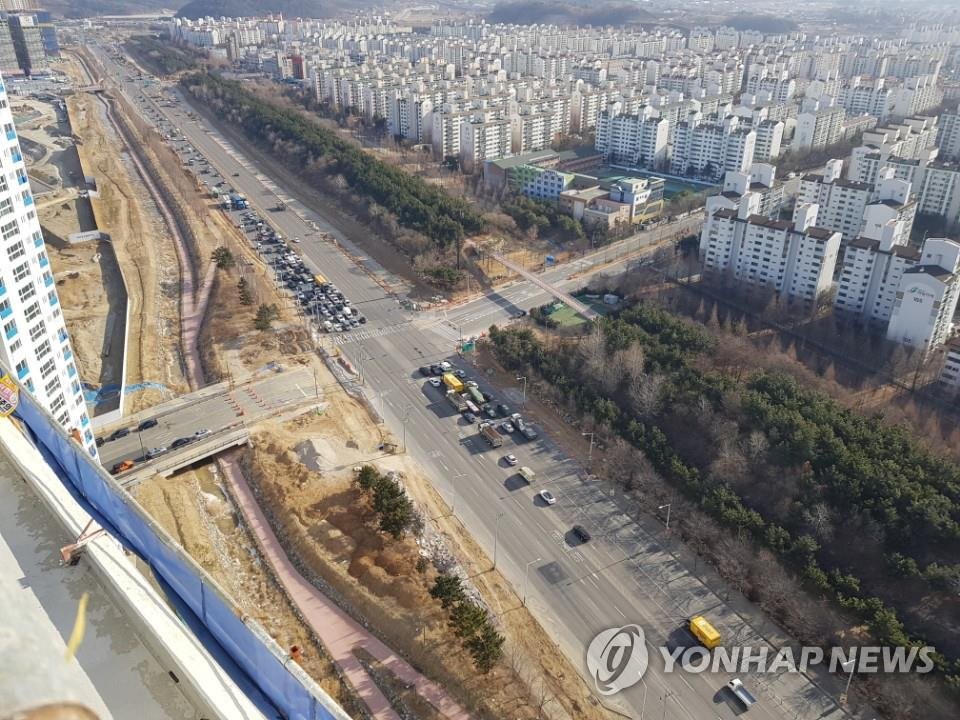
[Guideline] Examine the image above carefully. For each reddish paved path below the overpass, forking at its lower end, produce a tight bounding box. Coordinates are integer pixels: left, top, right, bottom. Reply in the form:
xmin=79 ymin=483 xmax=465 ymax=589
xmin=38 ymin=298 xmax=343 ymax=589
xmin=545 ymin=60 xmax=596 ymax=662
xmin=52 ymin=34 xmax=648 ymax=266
xmin=220 ymin=457 xmax=470 ymax=720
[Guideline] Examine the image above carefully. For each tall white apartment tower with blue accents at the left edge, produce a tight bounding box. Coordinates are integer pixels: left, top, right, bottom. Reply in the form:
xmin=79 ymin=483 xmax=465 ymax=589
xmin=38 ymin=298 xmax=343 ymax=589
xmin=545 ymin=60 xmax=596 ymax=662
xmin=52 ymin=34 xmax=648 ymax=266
xmin=0 ymin=78 xmax=97 ymax=457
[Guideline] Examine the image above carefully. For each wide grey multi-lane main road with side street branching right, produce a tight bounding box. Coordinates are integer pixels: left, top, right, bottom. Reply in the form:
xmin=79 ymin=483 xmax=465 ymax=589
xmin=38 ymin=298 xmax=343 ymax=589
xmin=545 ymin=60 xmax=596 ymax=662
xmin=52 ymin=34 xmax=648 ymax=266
xmin=94 ymin=48 xmax=844 ymax=720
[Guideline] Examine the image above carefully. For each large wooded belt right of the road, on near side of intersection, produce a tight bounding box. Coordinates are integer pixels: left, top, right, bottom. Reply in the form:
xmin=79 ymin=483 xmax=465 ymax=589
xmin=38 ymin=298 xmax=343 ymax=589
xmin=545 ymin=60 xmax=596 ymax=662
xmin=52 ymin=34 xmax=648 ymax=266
xmin=489 ymin=302 xmax=960 ymax=683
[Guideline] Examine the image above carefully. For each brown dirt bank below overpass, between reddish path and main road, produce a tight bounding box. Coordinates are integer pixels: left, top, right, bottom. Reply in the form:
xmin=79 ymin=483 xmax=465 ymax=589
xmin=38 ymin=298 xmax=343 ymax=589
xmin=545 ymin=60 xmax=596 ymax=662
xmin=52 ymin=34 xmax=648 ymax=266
xmin=245 ymin=388 xmax=606 ymax=718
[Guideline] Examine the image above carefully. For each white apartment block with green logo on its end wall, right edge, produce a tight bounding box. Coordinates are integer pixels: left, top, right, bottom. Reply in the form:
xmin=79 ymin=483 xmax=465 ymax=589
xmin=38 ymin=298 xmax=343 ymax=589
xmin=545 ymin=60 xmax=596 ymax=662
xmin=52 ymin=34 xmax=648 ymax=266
xmin=887 ymin=238 xmax=960 ymax=350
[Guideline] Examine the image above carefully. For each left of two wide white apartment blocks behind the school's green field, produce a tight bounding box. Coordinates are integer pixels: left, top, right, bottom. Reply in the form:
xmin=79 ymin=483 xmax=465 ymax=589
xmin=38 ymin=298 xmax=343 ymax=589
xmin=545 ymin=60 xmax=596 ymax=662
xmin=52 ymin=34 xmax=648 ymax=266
xmin=595 ymin=108 xmax=670 ymax=170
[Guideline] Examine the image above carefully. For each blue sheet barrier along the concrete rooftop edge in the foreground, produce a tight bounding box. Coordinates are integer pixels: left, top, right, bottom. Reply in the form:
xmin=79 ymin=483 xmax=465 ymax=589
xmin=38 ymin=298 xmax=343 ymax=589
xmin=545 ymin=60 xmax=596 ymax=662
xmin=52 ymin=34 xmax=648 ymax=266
xmin=14 ymin=380 xmax=348 ymax=720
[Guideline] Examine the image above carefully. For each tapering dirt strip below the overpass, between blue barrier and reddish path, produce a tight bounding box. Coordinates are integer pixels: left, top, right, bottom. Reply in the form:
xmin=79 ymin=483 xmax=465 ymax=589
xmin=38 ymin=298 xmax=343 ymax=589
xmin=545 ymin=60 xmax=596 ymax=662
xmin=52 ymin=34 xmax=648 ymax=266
xmin=133 ymin=466 xmax=353 ymax=706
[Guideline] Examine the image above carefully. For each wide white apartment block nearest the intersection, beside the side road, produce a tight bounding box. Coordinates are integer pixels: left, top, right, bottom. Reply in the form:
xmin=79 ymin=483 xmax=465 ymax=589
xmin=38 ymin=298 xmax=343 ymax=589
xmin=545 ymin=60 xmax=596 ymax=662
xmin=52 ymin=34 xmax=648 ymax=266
xmin=700 ymin=203 xmax=840 ymax=303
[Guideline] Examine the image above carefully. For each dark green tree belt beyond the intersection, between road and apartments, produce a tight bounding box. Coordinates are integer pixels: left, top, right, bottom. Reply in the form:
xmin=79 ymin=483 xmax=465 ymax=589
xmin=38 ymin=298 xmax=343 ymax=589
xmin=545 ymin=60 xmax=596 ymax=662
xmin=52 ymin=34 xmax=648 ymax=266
xmin=181 ymin=73 xmax=484 ymax=249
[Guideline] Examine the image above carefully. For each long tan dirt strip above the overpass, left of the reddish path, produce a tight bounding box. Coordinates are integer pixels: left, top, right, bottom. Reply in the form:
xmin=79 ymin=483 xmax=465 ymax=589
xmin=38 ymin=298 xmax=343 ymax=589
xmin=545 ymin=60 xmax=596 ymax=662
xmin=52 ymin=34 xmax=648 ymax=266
xmin=67 ymin=83 xmax=186 ymax=412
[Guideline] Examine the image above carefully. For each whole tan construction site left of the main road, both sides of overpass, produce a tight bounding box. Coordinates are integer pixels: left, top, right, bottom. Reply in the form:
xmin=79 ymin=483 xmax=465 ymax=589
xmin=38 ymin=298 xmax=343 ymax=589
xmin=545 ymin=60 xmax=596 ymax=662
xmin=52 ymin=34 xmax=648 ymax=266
xmin=0 ymin=51 xmax=605 ymax=719
